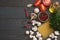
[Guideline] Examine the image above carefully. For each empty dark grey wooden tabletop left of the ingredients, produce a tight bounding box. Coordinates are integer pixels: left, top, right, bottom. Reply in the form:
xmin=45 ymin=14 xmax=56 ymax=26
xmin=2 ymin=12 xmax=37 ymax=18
xmin=0 ymin=0 xmax=60 ymax=40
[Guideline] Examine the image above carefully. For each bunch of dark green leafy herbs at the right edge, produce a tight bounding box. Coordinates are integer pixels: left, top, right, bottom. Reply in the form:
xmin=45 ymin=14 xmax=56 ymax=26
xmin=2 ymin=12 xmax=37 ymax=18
xmin=50 ymin=10 xmax=60 ymax=31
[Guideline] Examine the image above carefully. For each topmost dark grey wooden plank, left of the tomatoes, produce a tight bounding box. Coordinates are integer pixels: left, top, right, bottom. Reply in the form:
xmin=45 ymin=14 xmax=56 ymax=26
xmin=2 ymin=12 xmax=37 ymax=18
xmin=0 ymin=0 xmax=34 ymax=7
